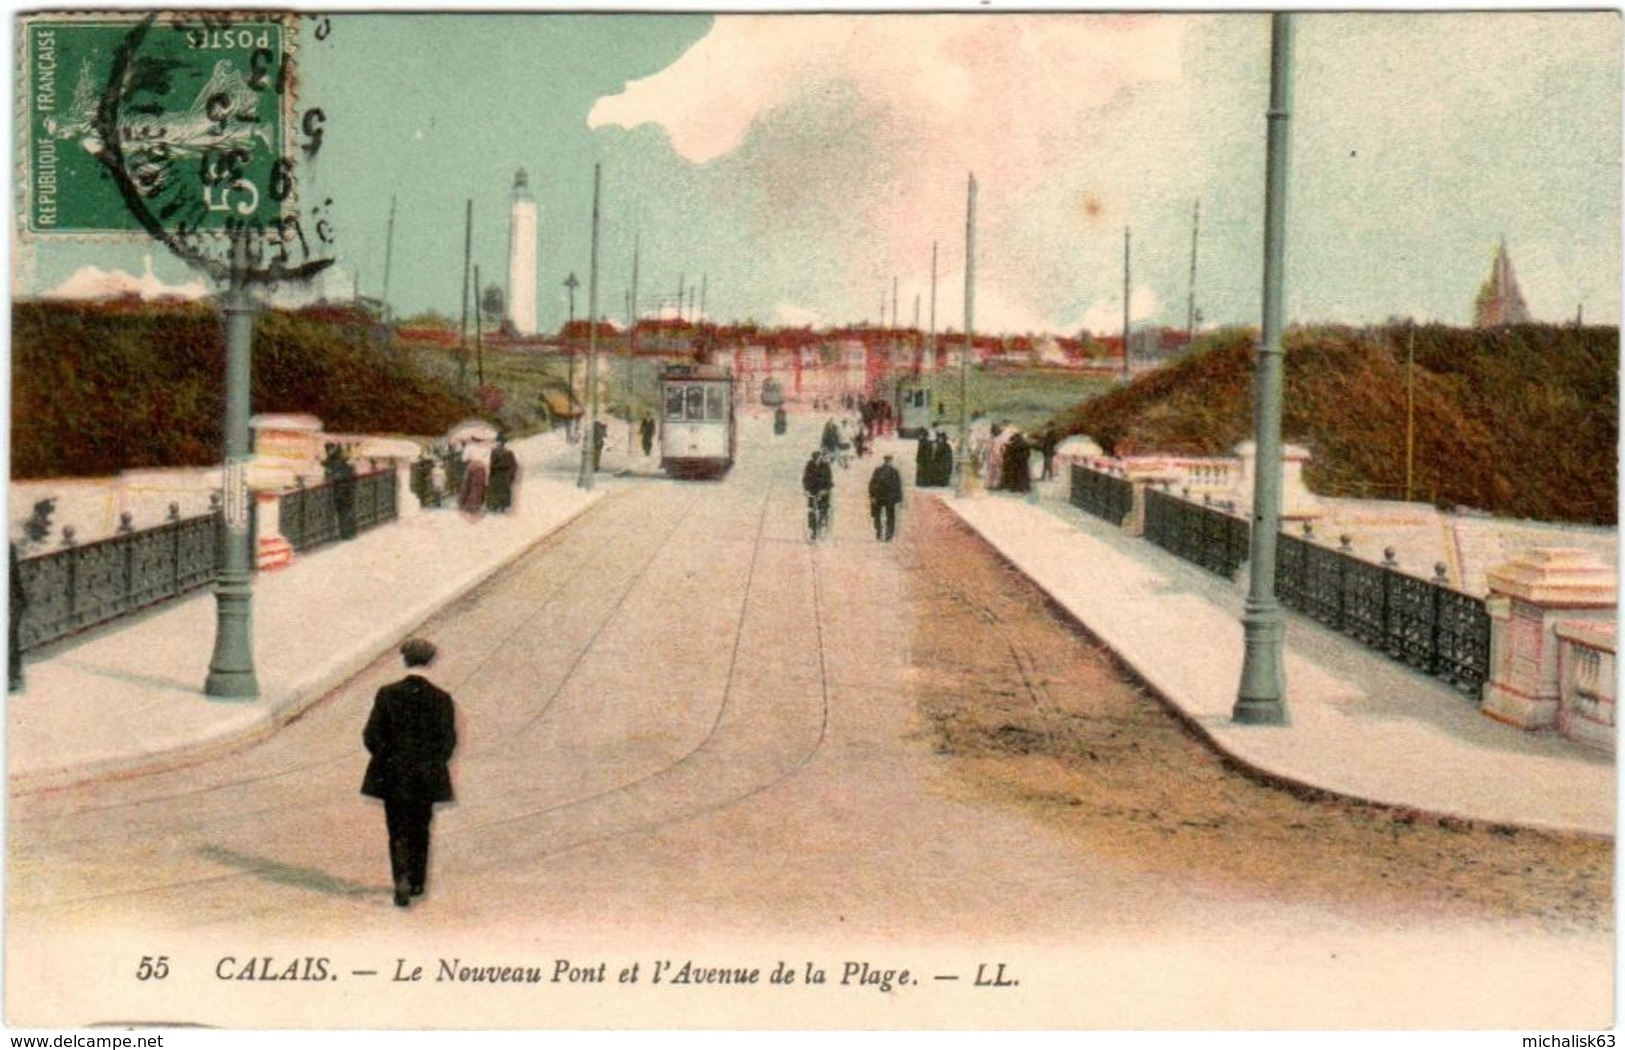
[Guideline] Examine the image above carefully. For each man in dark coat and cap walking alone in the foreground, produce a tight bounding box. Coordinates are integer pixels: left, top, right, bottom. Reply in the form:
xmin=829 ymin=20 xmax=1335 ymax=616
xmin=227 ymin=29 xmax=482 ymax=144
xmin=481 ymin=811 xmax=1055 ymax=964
xmin=361 ymin=639 xmax=457 ymax=907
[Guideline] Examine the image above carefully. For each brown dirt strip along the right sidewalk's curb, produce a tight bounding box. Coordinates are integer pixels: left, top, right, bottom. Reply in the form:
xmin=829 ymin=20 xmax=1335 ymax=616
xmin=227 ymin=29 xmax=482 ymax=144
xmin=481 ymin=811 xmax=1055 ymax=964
xmin=905 ymin=499 xmax=1614 ymax=930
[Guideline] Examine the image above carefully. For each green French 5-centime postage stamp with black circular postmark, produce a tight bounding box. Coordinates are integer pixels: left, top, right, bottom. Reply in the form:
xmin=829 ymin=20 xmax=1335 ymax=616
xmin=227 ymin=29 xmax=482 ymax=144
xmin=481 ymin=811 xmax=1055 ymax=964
xmin=18 ymin=13 xmax=294 ymax=236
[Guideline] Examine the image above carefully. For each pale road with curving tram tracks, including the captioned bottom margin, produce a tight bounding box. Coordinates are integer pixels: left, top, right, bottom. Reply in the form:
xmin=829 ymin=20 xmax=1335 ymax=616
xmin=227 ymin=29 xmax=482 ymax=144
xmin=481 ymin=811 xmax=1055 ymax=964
xmin=7 ymin=419 xmax=1610 ymax=1027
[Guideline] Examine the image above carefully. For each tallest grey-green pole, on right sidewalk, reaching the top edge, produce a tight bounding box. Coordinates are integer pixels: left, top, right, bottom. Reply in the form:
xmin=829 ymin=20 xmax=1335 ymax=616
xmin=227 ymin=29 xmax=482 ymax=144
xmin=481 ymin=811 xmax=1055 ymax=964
xmin=1230 ymin=15 xmax=1292 ymax=725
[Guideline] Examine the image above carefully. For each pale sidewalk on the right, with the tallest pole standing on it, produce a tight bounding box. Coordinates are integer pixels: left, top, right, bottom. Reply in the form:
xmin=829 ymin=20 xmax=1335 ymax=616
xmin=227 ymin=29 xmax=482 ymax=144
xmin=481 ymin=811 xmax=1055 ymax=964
xmin=939 ymin=486 xmax=1615 ymax=837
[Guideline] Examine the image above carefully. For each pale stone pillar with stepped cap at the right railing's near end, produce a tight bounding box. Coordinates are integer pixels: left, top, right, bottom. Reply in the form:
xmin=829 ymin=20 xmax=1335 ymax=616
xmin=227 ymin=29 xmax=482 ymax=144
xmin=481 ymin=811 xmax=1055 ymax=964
xmin=1482 ymin=548 xmax=1619 ymax=730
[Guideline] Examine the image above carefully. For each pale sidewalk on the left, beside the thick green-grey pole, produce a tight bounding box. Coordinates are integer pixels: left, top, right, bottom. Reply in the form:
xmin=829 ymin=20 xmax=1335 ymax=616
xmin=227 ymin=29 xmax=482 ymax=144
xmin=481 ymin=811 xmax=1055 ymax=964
xmin=5 ymin=436 xmax=601 ymax=793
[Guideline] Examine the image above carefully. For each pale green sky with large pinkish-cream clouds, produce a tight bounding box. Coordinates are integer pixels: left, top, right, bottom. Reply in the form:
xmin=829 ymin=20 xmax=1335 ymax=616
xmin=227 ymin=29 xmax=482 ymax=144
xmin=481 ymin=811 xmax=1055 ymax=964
xmin=13 ymin=11 xmax=1622 ymax=333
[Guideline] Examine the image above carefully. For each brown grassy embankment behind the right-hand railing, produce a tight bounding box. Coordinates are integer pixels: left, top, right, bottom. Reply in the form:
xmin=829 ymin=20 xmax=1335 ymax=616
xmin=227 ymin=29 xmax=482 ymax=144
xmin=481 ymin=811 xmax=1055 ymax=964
xmin=1060 ymin=325 xmax=1619 ymax=525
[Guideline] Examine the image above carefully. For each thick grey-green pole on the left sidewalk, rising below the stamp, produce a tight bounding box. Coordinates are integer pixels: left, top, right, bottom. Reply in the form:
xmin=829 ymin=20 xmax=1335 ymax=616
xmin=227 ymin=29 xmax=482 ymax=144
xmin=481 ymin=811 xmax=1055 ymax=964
xmin=203 ymin=232 xmax=260 ymax=701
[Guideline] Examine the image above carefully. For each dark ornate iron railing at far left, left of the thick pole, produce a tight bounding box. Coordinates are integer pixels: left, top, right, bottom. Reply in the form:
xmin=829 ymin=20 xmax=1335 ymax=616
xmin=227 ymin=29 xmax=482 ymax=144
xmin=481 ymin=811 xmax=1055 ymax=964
xmin=18 ymin=514 xmax=219 ymax=652
